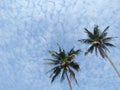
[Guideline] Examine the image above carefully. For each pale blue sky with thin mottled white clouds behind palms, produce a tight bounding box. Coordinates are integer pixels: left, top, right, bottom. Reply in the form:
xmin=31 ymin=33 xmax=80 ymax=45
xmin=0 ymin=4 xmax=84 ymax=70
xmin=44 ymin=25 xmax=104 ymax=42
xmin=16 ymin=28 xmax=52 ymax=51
xmin=0 ymin=0 xmax=120 ymax=90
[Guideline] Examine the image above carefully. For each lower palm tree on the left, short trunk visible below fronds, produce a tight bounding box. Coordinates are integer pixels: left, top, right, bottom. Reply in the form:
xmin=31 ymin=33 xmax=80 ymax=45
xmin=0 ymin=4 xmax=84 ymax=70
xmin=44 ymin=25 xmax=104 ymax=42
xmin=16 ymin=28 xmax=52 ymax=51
xmin=46 ymin=47 xmax=81 ymax=90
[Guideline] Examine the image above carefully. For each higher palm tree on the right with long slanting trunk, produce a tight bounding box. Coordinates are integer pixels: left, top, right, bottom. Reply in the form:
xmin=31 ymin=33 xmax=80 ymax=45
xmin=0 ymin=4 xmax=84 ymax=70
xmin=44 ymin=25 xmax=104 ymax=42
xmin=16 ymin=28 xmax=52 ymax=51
xmin=78 ymin=25 xmax=120 ymax=77
